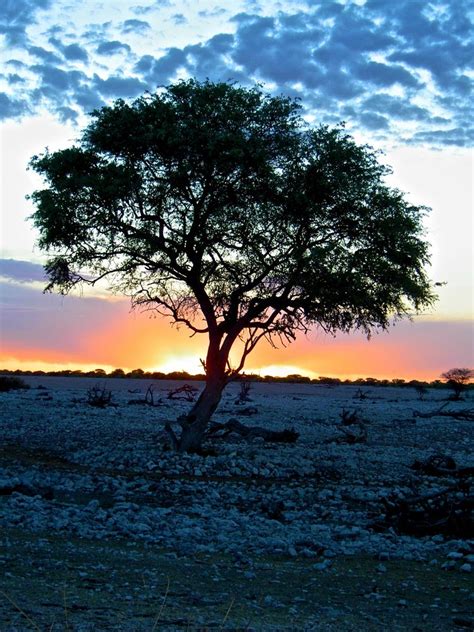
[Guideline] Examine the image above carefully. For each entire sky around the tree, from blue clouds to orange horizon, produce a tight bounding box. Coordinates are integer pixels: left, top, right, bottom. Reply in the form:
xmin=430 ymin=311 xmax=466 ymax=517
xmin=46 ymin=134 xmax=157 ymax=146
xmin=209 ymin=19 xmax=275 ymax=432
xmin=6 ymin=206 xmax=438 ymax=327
xmin=0 ymin=0 xmax=474 ymax=380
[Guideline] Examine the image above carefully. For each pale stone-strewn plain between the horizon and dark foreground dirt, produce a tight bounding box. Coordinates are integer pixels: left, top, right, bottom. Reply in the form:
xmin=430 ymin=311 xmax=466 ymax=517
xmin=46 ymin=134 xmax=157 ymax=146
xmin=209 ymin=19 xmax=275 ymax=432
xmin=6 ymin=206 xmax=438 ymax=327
xmin=0 ymin=376 xmax=474 ymax=573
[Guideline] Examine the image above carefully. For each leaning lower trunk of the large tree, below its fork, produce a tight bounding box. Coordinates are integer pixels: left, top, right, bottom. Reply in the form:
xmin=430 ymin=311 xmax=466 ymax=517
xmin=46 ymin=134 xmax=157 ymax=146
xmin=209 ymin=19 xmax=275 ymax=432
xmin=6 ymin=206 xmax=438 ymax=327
xmin=176 ymin=371 xmax=226 ymax=452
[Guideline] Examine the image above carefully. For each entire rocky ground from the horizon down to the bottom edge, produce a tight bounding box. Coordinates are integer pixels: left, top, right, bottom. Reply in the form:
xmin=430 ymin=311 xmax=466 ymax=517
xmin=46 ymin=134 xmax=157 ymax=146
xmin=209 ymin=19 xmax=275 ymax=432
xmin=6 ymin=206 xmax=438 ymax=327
xmin=0 ymin=377 xmax=474 ymax=631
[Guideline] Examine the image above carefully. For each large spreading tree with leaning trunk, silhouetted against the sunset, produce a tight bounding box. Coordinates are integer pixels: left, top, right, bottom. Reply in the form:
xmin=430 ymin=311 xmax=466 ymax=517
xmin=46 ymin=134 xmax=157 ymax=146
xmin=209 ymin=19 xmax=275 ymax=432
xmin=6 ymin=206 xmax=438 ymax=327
xmin=31 ymin=80 xmax=434 ymax=451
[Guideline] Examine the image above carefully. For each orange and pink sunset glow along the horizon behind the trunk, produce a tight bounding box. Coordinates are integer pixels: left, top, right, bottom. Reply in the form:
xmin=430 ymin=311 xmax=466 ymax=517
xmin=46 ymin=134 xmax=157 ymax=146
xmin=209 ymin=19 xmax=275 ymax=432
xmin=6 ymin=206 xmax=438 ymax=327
xmin=0 ymin=292 xmax=473 ymax=381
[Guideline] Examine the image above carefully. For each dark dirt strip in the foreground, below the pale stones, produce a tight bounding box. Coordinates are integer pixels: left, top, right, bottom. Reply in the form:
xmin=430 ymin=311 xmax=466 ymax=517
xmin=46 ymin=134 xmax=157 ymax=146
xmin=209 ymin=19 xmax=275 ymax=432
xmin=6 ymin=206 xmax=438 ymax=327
xmin=0 ymin=451 xmax=474 ymax=632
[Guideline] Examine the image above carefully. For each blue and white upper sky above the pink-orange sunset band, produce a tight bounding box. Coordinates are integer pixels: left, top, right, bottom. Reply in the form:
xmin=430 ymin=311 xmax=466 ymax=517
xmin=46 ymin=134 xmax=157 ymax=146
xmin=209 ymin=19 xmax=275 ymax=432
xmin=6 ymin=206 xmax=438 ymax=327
xmin=0 ymin=0 xmax=474 ymax=376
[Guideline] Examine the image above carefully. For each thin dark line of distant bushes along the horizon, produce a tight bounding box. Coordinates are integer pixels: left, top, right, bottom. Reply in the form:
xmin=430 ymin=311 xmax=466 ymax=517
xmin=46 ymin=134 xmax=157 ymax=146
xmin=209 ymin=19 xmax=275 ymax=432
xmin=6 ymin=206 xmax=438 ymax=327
xmin=0 ymin=369 xmax=468 ymax=389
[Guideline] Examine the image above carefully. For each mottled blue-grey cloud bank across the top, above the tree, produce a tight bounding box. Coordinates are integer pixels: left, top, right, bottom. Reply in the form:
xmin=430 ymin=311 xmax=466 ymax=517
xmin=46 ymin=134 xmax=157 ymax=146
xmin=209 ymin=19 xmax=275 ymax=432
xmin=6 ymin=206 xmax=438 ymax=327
xmin=0 ymin=0 xmax=474 ymax=147
